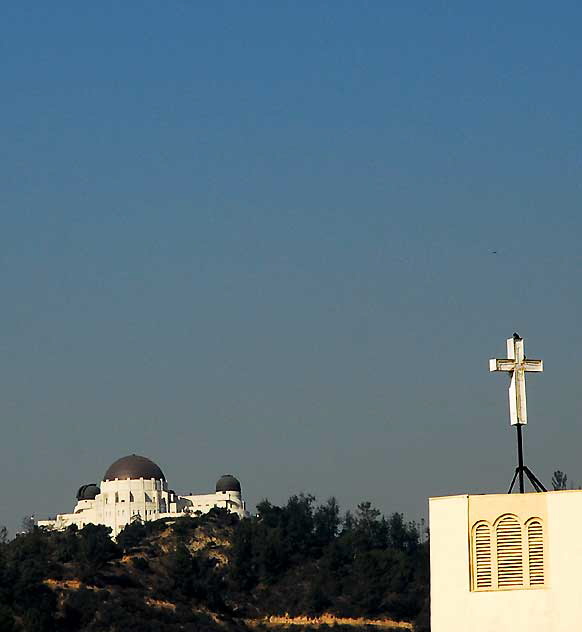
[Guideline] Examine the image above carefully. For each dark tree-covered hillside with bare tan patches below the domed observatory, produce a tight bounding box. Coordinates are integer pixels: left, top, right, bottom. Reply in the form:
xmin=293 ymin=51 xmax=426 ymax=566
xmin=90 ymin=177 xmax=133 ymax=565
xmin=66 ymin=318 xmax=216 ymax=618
xmin=0 ymin=495 xmax=428 ymax=632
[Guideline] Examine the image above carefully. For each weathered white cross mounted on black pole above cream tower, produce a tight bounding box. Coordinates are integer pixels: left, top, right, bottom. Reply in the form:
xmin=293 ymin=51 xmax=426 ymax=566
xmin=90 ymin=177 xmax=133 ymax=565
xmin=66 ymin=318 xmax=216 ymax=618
xmin=489 ymin=334 xmax=544 ymax=426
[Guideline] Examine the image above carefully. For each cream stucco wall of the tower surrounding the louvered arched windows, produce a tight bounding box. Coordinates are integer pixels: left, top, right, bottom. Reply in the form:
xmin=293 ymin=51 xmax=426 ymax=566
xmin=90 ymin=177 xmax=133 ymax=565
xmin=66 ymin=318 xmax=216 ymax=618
xmin=429 ymin=490 xmax=582 ymax=632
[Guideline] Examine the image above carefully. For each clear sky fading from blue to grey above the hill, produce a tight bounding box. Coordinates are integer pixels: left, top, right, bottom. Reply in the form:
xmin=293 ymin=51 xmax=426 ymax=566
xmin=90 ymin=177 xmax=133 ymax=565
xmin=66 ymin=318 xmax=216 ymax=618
xmin=0 ymin=0 xmax=582 ymax=532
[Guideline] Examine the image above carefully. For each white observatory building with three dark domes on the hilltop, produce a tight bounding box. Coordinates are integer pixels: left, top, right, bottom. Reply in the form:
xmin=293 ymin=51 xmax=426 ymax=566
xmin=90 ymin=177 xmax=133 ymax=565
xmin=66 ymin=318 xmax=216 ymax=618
xmin=38 ymin=454 xmax=249 ymax=537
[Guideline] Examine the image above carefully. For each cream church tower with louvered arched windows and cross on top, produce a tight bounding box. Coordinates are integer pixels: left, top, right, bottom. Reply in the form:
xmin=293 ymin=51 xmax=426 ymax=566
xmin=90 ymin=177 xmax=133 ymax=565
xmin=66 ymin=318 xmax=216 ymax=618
xmin=429 ymin=334 xmax=582 ymax=632
